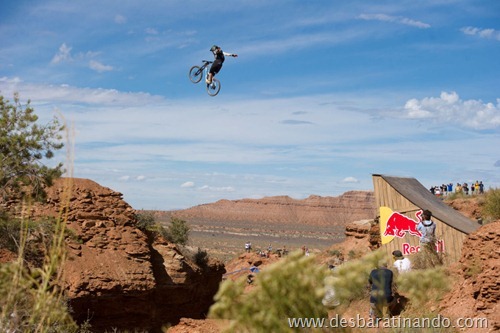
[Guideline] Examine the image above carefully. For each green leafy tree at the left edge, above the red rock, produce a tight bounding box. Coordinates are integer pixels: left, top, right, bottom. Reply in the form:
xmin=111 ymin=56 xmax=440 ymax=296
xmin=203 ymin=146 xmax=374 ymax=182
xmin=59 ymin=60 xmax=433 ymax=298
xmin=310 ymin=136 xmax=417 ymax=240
xmin=0 ymin=93 xmax=64 ymax=199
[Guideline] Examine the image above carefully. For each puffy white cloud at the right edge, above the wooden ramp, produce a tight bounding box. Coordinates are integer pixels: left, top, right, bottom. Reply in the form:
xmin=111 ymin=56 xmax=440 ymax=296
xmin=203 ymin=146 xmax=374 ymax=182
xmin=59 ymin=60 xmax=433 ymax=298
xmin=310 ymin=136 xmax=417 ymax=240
xmin=404 ymin=92 xmax=500 ymax=130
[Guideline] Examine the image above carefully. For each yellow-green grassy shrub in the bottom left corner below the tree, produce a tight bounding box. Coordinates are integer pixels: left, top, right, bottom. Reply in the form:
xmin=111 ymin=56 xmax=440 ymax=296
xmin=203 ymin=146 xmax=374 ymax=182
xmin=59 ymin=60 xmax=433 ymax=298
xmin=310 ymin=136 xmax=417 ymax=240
xmin=0 ymin=204 xmax=77 ymax=332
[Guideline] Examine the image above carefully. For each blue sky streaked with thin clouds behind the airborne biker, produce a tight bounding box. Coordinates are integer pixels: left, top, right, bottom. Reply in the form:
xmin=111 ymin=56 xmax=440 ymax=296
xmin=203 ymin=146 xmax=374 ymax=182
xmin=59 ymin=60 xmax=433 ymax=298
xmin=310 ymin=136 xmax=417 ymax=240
xmin=0 ymin=0 xmax=500 ymax=209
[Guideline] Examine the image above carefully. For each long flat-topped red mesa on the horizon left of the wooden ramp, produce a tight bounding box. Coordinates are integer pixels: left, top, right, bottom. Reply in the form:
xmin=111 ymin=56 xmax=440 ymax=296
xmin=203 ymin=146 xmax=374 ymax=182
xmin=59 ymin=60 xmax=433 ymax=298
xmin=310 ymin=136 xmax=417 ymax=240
xmin=164 ymin=191 xmax=375 ymax=227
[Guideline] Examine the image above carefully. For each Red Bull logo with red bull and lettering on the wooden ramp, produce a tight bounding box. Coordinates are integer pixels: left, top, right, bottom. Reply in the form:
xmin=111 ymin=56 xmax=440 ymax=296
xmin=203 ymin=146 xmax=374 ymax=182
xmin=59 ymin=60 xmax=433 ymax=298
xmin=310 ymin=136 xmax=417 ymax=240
xmin=380 ymin=207 xmax=444 ymax=255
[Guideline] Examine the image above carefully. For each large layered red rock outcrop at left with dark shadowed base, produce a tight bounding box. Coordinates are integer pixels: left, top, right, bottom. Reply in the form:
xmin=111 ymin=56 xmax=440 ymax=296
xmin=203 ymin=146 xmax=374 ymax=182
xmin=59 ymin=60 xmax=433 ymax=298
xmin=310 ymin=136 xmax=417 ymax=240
xmin=13 ymin=179 xmax=225 ymax=331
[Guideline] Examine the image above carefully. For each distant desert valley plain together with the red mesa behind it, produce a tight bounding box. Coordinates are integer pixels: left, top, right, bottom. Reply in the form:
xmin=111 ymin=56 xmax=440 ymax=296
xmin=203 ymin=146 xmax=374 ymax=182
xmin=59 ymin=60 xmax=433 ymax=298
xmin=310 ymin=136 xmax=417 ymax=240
xmin=155 ymin=191 xmax=376 ymax=261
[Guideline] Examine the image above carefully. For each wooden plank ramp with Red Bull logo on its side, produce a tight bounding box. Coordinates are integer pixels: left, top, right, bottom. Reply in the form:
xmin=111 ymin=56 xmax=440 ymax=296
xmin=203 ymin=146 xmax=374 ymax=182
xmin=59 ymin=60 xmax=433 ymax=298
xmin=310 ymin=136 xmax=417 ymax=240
xmin=372 ymin=174 xmax=480 ymax=264
